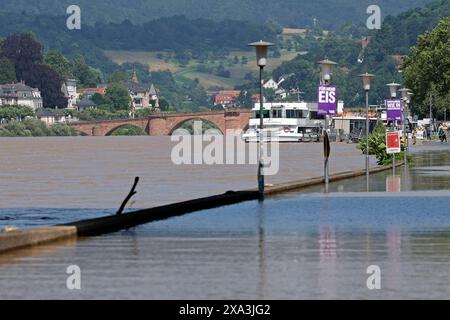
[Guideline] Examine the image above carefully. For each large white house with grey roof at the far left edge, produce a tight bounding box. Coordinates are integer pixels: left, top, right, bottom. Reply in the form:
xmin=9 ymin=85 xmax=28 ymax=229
xmin=0 ymin=82 xmax=43 ymax=111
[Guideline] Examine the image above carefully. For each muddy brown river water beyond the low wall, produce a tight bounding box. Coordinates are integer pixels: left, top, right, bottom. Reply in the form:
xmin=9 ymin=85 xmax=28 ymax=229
xmin=0 ymin=137 xmax=376 ymax=209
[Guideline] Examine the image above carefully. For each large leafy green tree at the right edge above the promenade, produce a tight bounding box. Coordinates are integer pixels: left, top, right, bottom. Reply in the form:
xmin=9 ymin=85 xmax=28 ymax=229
xmin=404 ymin=17 xmax=450 ymax=115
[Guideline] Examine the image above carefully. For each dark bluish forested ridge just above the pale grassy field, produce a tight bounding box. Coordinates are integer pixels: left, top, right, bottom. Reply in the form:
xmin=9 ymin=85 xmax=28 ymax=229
xmin=0 ymin=12 xmax=281 ymax=73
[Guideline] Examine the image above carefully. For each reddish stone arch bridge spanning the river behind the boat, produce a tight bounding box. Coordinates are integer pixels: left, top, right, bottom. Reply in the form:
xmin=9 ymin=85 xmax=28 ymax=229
xmin=69 ymin=110 xmax=252 ymax=136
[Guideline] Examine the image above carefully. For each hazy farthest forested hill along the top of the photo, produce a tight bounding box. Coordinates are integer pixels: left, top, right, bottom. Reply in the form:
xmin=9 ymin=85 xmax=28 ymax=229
xmin=0 ymin=0 xmax=430 ymax=29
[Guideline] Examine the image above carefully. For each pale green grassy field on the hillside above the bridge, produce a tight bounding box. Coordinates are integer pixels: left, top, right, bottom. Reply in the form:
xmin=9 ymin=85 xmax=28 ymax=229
xmin=105 ymin=50 xmax=301 ymax=89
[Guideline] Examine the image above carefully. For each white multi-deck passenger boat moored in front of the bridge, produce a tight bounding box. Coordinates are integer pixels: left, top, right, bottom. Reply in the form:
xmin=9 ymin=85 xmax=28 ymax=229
xmin=242 ymin=102 xmax=325 ymax=142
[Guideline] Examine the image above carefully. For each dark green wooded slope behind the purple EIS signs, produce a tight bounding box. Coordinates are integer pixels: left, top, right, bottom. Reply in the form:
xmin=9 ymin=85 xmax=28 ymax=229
xmin=258 ymin=0 xmax=450 ymax=106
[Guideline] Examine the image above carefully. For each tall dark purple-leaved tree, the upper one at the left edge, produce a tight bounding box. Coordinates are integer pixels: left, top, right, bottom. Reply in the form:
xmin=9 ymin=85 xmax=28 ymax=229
xmin=1 ymin=33 xmax=43 ymax=80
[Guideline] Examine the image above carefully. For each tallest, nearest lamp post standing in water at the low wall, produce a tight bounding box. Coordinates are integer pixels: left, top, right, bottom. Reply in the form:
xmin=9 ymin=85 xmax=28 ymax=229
xmin=249 ymin=40 xmax=274 ymax=200
